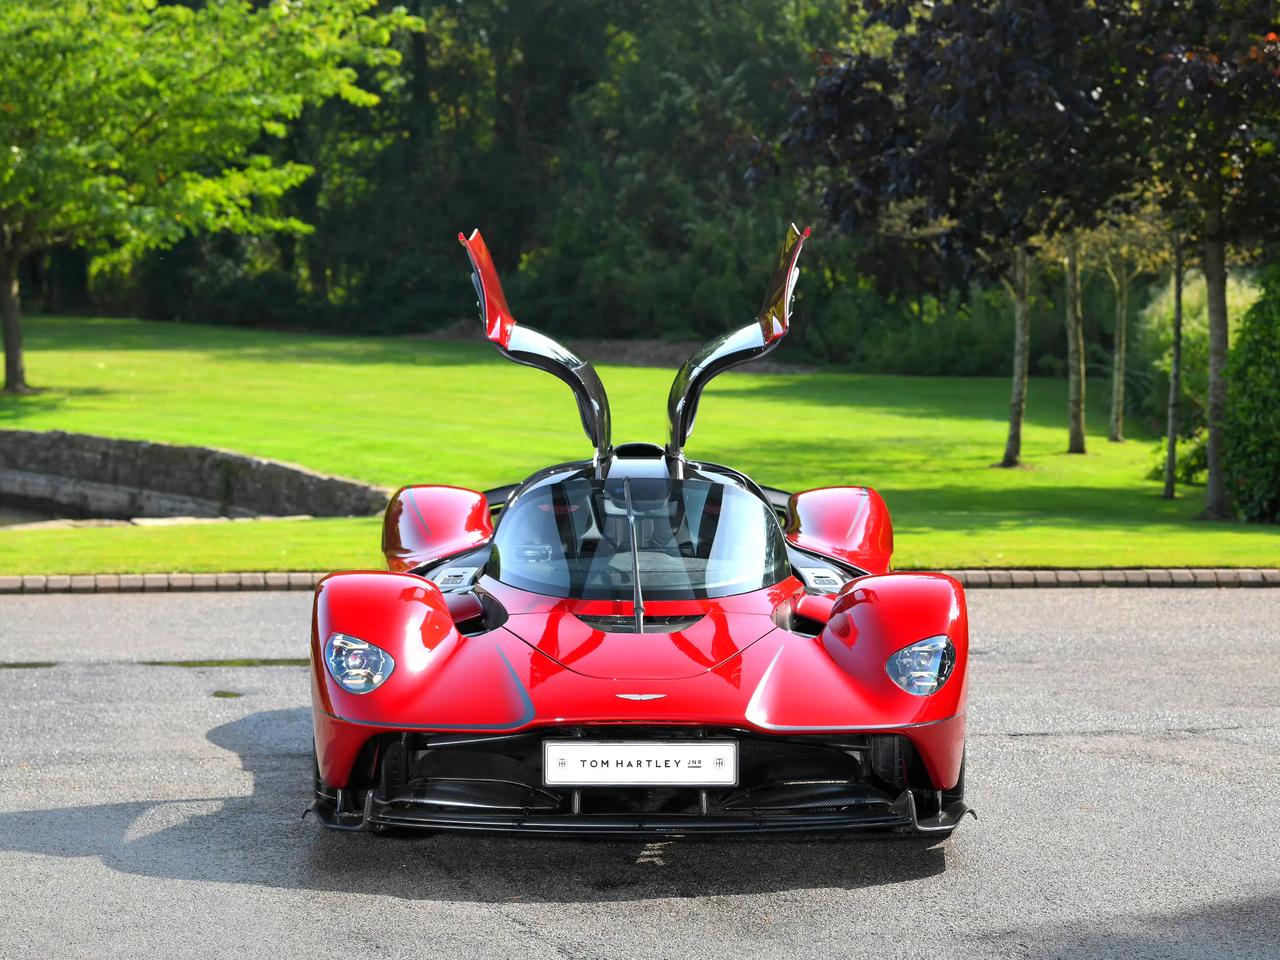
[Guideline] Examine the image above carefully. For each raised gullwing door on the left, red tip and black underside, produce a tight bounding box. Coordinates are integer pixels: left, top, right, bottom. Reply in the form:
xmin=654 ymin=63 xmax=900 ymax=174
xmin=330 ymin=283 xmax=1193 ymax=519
xmin=458 ymin=230 xmax=613 ymax=460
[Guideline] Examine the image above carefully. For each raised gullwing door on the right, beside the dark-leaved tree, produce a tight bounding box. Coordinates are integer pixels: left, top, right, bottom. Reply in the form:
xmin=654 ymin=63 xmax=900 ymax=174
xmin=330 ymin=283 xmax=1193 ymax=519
xmin=667 ymin=224 xmax=809 ymax=457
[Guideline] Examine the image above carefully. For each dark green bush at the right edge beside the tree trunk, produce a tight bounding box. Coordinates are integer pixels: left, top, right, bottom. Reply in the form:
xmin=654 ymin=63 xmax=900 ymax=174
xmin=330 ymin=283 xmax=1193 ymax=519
xmin=1224 ymin=265 xmax=1280 ymax=524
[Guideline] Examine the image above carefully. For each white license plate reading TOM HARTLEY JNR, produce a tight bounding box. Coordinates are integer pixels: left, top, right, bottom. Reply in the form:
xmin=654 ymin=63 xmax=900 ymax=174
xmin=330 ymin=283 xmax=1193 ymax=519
xmin=543 ymin=740 xmax=737 ymax=787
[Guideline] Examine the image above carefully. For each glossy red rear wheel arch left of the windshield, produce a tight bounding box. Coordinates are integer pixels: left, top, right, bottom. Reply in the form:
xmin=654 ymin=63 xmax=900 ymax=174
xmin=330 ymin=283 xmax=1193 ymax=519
xmin=383 ymin=485 xmax=493 ymax=572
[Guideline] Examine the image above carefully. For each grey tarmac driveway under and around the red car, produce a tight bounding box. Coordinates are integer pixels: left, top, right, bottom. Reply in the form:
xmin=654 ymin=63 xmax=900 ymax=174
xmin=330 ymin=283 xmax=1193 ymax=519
xmin=0 ymin=589 xmax=1280 ymax=960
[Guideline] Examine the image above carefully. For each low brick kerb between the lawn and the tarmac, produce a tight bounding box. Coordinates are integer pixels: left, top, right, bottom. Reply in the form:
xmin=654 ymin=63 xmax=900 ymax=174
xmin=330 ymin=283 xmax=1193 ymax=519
xmin=0 ymin=567 xmax=1280 ymax=594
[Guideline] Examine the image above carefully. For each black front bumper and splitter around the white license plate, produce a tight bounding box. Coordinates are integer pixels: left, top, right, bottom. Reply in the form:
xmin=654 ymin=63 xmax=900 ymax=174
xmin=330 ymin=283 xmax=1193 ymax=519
xmin=307 ymin=726 xmax=972 ymax=835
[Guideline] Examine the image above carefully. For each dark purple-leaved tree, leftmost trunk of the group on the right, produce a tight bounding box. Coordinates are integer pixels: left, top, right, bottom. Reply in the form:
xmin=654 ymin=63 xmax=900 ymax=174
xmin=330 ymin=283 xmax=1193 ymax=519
xmin=786 ymin=0 xmax=1139 ymax=466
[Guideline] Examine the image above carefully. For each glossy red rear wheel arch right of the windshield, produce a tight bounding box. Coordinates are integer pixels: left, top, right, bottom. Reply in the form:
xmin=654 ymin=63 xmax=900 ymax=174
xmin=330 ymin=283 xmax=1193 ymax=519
xmin=786 ymin=486 xmax=893 ymax=573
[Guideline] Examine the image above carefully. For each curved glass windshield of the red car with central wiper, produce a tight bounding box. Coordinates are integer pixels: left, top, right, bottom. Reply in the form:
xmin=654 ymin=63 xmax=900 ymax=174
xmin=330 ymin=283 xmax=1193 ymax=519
xmin=489 ymin=477 xmax=791 ymax=600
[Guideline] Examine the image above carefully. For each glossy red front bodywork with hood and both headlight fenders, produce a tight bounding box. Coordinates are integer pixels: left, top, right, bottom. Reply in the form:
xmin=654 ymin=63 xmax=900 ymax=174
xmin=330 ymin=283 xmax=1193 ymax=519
xmin=312 ymin=573 xmax=968 ymax=787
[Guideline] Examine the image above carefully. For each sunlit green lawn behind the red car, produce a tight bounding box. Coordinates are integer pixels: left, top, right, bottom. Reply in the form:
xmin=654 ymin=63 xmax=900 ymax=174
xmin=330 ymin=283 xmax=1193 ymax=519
xmin=0 ymin=317 xmax=1280 ymax=573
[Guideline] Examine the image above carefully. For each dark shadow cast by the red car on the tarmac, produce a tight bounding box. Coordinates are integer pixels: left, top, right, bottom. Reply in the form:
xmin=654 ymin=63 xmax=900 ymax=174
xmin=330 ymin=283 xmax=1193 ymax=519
xmin=0 ymin=708 xmax=946 ymax=902
